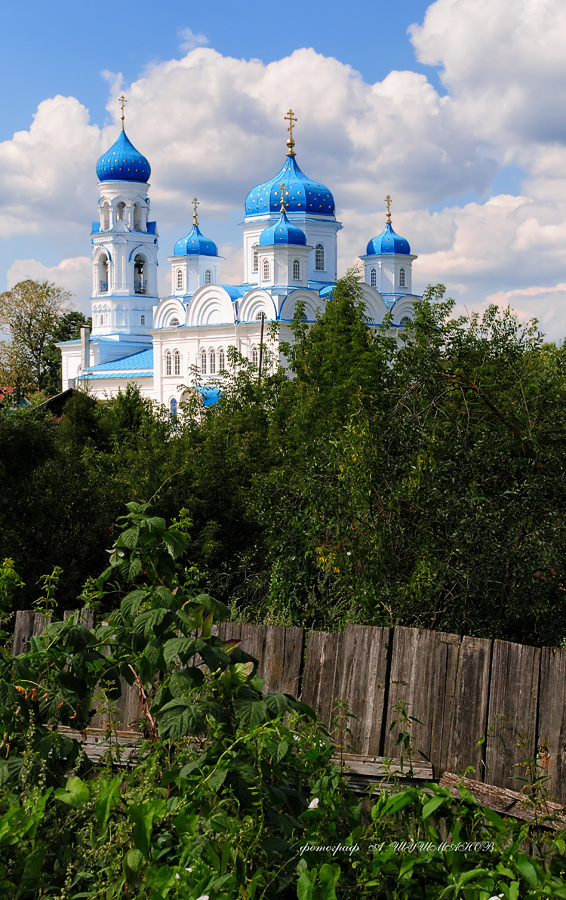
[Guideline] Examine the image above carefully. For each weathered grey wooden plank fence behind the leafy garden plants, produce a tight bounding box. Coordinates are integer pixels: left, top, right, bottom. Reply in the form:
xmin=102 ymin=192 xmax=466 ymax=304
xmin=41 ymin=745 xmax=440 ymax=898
xmin=13 ymin=611 xmax=566 ymax=802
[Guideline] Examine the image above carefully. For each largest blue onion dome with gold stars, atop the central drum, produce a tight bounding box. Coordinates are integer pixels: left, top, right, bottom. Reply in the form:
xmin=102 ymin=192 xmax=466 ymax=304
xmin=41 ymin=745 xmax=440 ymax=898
xmin=245 ymin=156 xmax=335 ymax=218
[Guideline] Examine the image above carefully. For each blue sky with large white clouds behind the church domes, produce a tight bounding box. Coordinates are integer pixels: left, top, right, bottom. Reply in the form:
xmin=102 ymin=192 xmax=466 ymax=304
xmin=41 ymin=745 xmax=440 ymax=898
xmin=0 ymin=0 xmax=566 ymax=340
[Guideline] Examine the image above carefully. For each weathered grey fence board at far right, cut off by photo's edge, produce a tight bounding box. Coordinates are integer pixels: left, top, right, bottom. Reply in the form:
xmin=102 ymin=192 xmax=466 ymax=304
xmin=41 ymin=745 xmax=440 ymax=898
xmin=538 ymin=647 xmax=566 ymax=802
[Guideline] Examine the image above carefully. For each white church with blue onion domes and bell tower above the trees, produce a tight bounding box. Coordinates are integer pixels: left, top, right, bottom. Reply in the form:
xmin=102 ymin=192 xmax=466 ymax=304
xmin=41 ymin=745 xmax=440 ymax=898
xmin=58 ymin=107 xmax=417 ymax=415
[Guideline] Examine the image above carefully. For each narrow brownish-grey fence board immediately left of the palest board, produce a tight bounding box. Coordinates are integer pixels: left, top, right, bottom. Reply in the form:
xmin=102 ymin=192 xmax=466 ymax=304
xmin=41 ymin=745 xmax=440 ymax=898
xmin=300 ymin=631 xmax=343 ymax=727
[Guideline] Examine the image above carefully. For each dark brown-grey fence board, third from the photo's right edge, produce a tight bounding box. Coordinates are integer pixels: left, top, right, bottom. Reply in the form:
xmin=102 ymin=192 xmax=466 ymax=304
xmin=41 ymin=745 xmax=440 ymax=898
xmin=441 ymin=637 xmax=493 ymax=780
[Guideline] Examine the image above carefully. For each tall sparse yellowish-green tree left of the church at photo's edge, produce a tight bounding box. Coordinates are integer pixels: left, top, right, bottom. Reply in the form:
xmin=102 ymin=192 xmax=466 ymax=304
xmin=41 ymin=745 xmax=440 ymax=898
xmin=0 ymin=279 xmax=71 ymax=390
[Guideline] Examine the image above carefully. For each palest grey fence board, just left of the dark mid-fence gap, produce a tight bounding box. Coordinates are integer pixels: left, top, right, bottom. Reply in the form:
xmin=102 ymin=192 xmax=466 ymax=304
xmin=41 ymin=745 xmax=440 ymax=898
xmin=333 ymin=625 xmax=390 ymax=754
